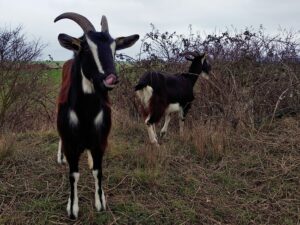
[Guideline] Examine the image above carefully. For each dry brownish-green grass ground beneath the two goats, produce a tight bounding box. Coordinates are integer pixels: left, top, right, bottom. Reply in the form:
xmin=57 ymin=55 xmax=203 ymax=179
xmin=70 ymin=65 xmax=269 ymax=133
xmin=0 ymin=64 xmax=300 ymax=225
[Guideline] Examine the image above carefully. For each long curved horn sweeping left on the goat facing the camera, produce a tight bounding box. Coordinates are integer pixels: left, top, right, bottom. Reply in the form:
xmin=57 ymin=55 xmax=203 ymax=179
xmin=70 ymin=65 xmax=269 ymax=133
xmin=54 ymin=12 xmax=96 ymax=33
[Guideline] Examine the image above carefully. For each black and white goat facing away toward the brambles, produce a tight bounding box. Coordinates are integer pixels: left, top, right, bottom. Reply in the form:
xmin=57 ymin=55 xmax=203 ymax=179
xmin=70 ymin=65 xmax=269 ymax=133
xmin=135 ymin=52 xmax=211 ymax=145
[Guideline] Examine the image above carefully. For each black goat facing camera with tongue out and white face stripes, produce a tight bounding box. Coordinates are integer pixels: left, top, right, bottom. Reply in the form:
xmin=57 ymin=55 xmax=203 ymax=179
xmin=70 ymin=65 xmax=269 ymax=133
xmin=54 ymin=13 xmax=139 ymax=218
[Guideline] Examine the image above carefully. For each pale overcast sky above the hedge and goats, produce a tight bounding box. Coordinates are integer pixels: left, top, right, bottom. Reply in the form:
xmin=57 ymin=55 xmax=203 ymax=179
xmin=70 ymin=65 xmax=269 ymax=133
xmin=0 ymin=0 xmax=300 ymax=60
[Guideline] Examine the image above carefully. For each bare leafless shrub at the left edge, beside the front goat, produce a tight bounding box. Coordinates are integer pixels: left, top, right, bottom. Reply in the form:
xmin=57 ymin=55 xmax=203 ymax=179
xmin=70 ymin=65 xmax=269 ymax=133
xmin=0 ymin=27 xmax=53 ymax=131
